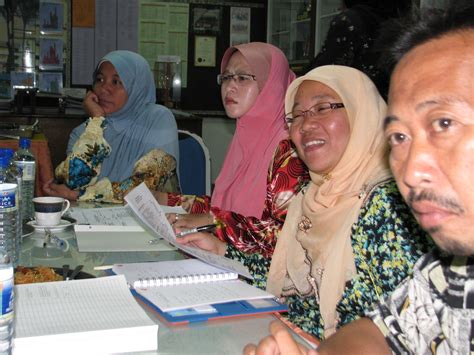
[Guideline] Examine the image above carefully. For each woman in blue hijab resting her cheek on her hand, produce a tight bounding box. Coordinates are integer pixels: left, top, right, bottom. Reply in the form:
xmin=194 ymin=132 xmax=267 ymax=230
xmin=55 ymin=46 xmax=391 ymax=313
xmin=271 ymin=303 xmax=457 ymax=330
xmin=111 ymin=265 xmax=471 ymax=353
xmin=44 ymin=50 xmax=179 ymax=202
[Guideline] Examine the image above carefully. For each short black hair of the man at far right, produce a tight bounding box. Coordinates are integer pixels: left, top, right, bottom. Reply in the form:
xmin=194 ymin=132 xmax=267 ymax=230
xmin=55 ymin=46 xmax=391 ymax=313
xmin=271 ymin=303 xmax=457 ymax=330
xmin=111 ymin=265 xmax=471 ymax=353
xmin=378 ymin=0 xmax=474 ymax=73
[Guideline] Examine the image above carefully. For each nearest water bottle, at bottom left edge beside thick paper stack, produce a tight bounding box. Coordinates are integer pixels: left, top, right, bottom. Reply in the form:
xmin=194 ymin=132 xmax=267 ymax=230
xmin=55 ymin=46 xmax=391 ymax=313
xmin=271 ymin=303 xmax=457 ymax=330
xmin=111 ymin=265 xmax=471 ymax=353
xmin=0 ymin=253 xmax=14 ymax=355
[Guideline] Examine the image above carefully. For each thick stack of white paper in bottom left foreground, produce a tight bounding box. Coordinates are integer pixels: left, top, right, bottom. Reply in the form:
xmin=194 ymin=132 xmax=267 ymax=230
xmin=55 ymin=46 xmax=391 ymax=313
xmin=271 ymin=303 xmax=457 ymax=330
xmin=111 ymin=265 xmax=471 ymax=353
xmin=14 ymin=276 xmax=158 ymax=355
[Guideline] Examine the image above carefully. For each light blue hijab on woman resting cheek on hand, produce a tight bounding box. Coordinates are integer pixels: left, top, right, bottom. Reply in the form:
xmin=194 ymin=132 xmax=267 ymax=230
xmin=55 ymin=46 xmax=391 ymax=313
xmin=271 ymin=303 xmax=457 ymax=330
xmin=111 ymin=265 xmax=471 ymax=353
xmin=68 ymin=50 xmax=179 ymax=182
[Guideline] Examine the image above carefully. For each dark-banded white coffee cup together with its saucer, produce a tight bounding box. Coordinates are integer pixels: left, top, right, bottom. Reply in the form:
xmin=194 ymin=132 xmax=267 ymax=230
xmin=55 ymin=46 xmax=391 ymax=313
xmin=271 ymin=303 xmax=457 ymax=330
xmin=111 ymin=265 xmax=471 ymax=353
xmin=27 ymin=196 xmax=76 ymax=232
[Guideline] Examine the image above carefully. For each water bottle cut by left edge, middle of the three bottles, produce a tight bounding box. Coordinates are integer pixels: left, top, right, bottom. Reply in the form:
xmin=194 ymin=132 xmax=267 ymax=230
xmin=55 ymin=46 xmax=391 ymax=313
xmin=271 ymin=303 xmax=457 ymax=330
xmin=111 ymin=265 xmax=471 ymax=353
xmin=0 ymin=153 xmax=21 ymax=266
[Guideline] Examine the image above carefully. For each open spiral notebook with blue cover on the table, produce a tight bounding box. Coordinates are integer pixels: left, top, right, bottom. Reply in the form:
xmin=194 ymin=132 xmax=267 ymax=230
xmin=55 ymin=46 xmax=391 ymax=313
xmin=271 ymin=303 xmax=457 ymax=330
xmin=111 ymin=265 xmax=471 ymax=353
xmin=112 ymin=259 xmax=286 ymax=324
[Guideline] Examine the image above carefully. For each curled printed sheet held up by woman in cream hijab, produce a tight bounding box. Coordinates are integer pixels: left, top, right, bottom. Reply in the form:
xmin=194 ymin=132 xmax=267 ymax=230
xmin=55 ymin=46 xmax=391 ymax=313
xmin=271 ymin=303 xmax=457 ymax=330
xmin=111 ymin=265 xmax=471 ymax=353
xmin=125 ymin=183 xmax=252 ymax=279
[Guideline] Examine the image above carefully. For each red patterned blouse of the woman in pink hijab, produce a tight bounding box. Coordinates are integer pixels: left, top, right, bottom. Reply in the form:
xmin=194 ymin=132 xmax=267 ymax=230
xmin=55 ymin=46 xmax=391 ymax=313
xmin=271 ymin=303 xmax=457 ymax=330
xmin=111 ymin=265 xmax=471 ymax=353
xmin=168 ymin=139 xmax=309 ymax=257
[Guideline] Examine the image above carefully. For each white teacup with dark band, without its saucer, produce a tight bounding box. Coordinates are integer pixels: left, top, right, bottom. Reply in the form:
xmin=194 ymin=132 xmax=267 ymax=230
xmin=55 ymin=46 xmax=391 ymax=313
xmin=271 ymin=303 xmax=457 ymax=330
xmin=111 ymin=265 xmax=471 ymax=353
xmin=33 ymin=196 xmax=70 ymax=226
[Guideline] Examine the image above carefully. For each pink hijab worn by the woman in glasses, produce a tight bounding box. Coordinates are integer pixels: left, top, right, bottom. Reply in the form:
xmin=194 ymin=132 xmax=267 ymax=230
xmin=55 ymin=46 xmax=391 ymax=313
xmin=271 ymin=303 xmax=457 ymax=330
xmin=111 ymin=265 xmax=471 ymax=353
xmin=211 ymin=42 xmax=295 ymax=218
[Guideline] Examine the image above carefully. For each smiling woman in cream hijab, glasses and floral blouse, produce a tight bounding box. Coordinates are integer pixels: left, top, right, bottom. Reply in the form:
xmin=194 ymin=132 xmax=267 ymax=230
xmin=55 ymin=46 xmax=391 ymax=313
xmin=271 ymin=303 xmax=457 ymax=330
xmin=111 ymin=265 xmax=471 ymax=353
xmin=262 ymin=65 xmax=434 ymax=338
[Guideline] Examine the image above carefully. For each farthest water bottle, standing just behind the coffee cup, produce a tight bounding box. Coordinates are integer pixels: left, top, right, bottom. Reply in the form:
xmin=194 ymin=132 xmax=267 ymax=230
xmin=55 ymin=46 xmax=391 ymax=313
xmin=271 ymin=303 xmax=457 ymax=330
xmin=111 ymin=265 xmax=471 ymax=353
xmin=13 ymin=137 xmax=36 ymax=221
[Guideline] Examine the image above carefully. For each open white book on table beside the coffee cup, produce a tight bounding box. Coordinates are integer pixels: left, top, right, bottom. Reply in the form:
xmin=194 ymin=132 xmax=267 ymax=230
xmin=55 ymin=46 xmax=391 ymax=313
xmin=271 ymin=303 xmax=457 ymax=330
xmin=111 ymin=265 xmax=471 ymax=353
xmin=70 ymin=206 xmax=184 ymax=252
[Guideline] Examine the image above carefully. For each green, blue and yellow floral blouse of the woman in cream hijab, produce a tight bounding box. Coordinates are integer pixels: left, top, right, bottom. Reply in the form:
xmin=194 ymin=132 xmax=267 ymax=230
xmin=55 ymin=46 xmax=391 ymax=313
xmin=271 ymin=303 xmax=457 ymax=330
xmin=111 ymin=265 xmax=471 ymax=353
xmin=226 ymin=180 xmax=433 ymax=339
